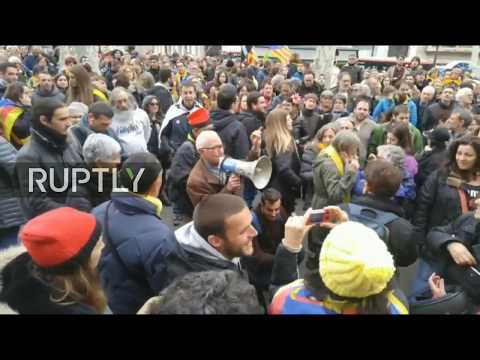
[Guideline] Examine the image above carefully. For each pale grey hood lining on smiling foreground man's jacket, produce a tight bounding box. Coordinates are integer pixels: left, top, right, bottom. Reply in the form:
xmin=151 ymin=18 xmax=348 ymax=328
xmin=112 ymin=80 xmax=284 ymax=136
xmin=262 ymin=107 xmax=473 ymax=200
xmin=175 ymin=221 xmax=240 ymax=266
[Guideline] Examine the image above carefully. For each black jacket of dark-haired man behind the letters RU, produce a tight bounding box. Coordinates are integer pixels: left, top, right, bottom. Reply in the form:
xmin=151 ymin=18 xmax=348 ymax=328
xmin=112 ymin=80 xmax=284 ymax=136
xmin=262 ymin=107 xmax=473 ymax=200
xmin=15 ymin=127 xmax=85 ymax=219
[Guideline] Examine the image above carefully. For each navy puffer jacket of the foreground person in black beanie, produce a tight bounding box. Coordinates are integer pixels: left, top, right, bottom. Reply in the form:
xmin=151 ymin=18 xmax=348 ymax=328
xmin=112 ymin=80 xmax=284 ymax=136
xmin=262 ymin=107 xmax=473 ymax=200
xmin=92 ymin=193 xmax=176 ymax=314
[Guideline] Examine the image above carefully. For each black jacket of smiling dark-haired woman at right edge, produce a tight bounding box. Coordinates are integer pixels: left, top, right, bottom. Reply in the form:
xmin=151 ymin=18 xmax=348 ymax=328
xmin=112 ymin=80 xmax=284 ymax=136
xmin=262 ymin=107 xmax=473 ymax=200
xmin=413 ymin=169 xmax=462 ymax=247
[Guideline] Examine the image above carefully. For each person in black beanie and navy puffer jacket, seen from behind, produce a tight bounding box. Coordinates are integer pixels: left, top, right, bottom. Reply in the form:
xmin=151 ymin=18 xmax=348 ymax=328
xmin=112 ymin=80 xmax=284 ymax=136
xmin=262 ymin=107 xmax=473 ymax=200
xmin=92 ymin=152 xmax=175 ymax=314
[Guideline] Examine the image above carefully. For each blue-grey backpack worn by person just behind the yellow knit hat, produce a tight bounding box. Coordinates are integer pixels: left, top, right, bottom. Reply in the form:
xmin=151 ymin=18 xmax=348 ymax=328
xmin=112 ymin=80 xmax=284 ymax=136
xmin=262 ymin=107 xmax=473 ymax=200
xmin=347 ymin=204 xmax=400 ymax=248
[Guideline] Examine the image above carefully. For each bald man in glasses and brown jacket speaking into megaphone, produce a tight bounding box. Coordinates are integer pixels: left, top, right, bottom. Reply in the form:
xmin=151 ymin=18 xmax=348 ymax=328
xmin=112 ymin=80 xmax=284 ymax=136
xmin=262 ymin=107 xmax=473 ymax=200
xmin=187 ymin=130 xmax=243 ymax=207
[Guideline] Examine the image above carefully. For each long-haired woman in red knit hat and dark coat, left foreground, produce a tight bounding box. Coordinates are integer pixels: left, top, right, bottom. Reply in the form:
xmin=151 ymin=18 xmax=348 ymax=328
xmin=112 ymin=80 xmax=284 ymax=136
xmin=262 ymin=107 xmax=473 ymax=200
xmin=0 ymin=207 xmax=107 ymax=315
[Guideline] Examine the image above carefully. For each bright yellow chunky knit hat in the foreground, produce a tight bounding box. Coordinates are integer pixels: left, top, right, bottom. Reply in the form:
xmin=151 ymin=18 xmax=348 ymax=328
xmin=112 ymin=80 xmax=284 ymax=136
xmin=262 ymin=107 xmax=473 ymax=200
xmin=320 ymin=221 xmax=395 ymax=298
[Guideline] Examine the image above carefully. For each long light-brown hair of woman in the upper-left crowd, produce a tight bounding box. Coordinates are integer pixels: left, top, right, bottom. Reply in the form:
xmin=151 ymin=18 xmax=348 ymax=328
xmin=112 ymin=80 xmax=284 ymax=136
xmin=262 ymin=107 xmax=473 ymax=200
xmin=67 ymin=65 xmax=105 ymax=106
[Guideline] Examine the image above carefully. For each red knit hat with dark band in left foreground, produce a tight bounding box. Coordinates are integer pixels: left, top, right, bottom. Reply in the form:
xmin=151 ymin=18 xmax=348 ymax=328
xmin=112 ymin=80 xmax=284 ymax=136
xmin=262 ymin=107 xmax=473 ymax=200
xmin=20 ymin=207 xmax=102 ymax=273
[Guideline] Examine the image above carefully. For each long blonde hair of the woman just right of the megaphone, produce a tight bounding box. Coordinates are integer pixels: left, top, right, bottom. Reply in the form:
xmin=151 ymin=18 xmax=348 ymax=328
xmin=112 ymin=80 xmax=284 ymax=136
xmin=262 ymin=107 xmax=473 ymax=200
xmin=264 ymin=109 xmax=294 ymax=157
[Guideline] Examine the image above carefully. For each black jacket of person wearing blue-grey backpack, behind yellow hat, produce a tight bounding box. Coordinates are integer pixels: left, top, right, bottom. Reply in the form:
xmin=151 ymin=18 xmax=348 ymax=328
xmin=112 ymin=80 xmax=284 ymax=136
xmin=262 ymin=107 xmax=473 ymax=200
xmin=340 ymin=195 xmax=417 ymax=266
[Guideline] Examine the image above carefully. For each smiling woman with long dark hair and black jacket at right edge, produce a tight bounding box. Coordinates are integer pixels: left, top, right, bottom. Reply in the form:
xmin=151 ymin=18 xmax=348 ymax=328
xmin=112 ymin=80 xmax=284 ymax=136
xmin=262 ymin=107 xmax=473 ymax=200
xmin=412 ymin=135 xmax=480 ymax=297
